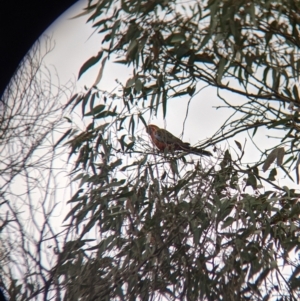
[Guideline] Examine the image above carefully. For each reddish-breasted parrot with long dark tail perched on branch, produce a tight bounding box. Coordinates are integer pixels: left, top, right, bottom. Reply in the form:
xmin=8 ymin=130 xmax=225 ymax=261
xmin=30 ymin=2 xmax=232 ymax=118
xmin=147 ymin=124 xmax=212 ymax=156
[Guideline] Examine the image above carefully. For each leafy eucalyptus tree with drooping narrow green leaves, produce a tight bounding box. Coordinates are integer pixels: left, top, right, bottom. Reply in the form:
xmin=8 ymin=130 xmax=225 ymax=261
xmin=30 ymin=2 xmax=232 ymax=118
xmin=54 ymin=0 xmax=300 ymax=300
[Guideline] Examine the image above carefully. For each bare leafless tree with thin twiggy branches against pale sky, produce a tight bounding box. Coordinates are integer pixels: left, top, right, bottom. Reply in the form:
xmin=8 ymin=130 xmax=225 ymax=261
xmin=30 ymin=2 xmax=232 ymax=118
xmin=0 ymin=37 xmax=74 ymax=300
